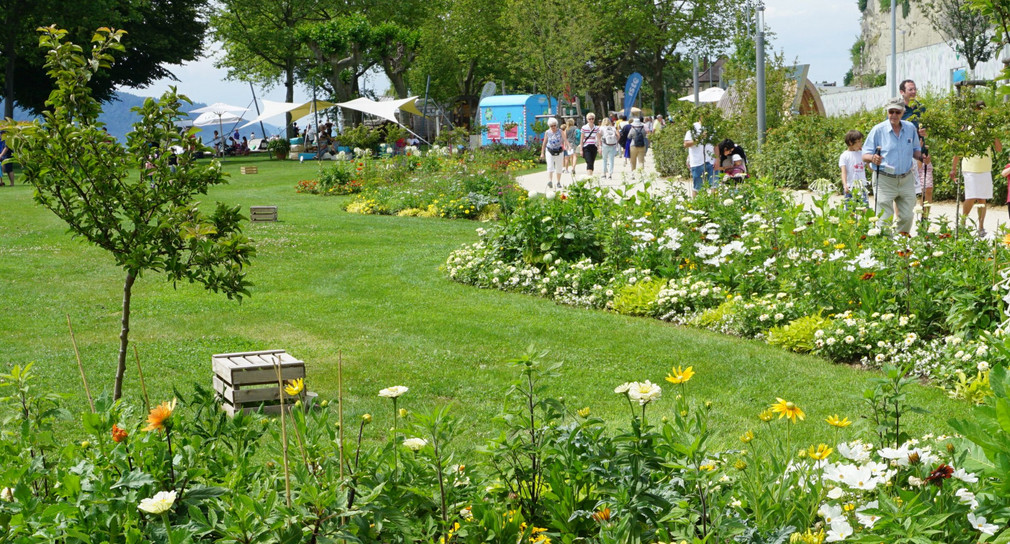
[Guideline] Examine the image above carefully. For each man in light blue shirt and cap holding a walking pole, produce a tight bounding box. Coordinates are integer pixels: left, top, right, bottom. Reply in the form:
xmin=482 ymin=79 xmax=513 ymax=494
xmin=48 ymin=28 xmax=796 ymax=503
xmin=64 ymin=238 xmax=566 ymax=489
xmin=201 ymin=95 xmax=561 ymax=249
xmin=863 ymin=97 xmax=929 ymax=233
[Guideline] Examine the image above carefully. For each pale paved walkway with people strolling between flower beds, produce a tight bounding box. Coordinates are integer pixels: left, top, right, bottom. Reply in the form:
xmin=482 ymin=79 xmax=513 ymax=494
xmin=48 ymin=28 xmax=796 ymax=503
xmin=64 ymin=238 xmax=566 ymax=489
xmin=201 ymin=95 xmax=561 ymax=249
xmin=517 ymin=150 xmax=1008 ymax=236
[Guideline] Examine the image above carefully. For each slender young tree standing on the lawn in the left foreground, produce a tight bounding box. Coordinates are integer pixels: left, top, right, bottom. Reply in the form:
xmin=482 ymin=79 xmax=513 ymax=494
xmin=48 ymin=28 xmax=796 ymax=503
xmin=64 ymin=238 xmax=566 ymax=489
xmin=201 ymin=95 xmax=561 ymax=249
xmin=8 ymin=26 xmax=255 ymax=399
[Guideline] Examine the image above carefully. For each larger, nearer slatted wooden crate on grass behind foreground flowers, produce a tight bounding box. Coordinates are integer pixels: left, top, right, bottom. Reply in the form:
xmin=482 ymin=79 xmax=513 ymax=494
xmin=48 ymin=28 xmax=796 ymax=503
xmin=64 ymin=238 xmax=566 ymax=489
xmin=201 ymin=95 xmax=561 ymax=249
xmin=211 ymin=349 xmax=305 ymax=416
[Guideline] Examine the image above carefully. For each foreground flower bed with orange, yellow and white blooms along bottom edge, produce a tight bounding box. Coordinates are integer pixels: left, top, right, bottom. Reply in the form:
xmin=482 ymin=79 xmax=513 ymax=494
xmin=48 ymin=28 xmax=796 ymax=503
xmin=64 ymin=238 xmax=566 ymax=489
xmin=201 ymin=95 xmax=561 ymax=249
xmin=0 ymin=351 xmax=1010 ymax=544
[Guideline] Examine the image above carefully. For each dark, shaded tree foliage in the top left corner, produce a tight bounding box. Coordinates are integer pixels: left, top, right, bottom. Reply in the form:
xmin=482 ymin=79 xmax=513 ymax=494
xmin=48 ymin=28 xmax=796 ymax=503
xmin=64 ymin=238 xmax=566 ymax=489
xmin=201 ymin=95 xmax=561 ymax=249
xmin=0 ymin=0 xmax=208 ymax=117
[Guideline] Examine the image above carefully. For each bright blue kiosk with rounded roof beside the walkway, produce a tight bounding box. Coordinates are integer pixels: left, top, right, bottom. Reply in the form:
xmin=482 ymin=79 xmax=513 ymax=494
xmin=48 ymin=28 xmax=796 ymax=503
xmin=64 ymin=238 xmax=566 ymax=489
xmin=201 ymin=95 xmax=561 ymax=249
xmin=479 ymin=95 xmax=558 ymax=145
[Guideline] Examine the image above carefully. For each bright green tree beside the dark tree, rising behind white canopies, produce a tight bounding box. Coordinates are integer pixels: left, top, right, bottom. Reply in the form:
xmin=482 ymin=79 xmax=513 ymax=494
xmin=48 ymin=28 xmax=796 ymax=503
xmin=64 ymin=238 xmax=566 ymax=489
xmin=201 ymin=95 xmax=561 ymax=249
xmin=210 ymin=0 xmax=329 ymax=135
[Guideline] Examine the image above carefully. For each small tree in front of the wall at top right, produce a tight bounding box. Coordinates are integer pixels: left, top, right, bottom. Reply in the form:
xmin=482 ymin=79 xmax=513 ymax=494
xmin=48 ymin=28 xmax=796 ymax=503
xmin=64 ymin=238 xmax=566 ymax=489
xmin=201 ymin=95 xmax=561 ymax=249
xmin=922 ymin=0 xmax=1000 ymax=71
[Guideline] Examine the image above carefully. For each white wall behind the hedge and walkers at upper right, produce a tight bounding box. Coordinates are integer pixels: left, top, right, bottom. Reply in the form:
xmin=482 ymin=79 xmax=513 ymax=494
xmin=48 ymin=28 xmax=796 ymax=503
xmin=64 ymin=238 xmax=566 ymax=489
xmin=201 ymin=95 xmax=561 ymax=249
xmin=821 ymin=43 xmax=1003 ymax=115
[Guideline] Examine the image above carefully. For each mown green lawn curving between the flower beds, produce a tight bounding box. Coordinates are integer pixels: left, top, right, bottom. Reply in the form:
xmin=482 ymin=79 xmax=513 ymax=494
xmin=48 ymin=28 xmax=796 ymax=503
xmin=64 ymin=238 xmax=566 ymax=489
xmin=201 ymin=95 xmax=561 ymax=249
xmin=0 ymin=157 xmax=968 ymax=445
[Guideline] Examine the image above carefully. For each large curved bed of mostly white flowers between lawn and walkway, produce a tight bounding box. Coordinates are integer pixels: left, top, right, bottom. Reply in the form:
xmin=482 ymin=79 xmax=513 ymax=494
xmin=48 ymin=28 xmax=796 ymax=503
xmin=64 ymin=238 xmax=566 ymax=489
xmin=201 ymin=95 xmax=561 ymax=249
xmin=445 ymin=182 xmax=1010 ymax=400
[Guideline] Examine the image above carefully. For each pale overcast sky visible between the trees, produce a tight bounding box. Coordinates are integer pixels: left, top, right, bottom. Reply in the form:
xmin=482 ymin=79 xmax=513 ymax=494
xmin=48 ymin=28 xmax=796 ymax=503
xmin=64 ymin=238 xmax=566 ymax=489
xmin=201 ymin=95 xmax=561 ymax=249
xmin=124 ymin=0 xmax=860 ymax=107
